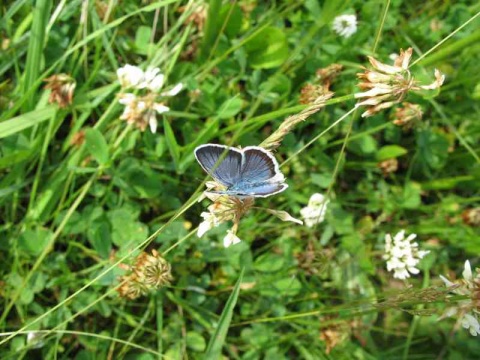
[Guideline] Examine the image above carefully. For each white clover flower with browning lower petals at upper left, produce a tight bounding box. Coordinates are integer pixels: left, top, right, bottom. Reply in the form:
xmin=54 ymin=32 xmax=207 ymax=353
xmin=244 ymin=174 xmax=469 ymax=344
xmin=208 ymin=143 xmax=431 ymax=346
xmin=117 ymin=64 xmax=183 ymax=133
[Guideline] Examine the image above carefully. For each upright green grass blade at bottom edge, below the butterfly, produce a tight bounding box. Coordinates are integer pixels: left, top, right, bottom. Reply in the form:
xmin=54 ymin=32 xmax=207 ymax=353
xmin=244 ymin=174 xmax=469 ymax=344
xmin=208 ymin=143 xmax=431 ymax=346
xmin=204 ymin=269 xmax=244 ymax=360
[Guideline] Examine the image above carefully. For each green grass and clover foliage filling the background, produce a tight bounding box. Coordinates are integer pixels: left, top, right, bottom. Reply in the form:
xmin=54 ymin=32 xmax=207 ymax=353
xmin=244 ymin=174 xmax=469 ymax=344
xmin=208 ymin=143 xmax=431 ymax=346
xmin=0 ymin=0 xmax=480 ymax=360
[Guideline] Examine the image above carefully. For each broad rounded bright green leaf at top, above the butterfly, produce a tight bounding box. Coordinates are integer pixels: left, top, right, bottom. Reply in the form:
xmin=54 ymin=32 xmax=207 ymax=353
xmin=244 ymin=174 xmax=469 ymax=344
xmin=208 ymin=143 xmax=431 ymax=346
xmin=245 ymin=26 xmax=289 ymax=69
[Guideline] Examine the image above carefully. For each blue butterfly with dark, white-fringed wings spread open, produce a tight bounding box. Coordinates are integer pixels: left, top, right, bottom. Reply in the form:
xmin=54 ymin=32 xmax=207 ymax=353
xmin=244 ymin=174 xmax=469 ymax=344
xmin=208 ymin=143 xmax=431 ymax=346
xmin=195 ymin=144 xmax=288 ymax=197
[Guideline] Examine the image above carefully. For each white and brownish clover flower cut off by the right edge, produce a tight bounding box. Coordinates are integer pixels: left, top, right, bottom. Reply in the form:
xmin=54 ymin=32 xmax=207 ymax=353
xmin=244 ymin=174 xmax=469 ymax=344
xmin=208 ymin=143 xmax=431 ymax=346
xmin=440 ymin=260 xmax=480 ymax=336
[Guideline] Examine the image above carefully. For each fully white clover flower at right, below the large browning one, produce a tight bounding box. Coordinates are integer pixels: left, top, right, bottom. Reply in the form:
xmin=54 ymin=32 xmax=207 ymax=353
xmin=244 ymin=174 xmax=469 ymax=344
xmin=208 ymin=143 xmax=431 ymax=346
xmin=383 ymin=230 xmax=430 ymax=280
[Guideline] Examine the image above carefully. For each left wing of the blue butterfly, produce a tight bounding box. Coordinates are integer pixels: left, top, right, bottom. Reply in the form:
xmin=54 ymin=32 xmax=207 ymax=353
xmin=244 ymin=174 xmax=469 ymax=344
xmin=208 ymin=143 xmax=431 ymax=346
xmin=195 ymin=144 xmax=243 ymax=187
